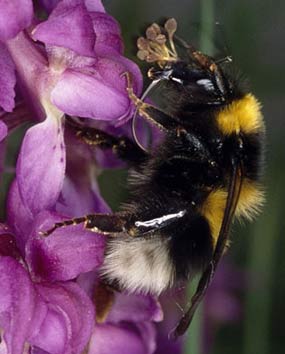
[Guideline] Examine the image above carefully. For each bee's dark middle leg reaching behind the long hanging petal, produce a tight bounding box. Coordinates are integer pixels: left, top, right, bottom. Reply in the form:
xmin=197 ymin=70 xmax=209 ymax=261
xmin=67 ymin=118 xmax=147 ymax=164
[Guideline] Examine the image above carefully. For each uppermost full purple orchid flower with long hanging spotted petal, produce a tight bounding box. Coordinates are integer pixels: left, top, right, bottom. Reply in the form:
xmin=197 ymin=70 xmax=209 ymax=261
xmin=0 ymin=0 xmax=142 ymax=214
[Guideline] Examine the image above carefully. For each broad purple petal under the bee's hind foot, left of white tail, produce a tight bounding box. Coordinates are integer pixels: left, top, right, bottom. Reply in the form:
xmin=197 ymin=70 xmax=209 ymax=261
xmin=26 ymin=212 xmax=105 ymax=281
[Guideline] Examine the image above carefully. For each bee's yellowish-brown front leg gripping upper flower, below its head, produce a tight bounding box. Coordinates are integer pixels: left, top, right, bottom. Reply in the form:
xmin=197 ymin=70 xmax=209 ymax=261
xmin=124 ymin=72 xmax=178 ymax=130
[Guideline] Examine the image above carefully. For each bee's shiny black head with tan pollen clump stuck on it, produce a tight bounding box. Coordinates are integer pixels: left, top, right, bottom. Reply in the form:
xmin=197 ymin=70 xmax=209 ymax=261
xmin=137 ymin=19 xmax=231 ymax=105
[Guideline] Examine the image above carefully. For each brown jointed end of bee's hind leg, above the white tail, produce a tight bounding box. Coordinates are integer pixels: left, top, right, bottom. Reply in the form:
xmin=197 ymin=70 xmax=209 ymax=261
xmin=41 ymin=213 xmax=131 ymax=236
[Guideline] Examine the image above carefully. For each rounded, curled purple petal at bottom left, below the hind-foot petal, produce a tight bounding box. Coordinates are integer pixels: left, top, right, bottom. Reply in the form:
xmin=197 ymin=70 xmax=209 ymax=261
xmin=29 ymin=283 xmax=95 ymax=354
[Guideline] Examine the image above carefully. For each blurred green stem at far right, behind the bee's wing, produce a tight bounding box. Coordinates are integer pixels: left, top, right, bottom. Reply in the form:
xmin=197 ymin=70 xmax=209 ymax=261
xmin=244 ymin=170 xmax=284 ymax=354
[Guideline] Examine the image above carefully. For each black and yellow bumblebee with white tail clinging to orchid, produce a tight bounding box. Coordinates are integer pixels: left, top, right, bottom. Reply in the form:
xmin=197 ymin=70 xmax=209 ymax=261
xmin=45 ymin=19 xmax=264 ymax=337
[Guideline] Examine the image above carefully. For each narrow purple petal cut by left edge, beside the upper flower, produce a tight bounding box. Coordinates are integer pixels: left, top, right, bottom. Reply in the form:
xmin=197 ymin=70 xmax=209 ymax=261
xmin=0 ymin=42 xmax=16 ymax=111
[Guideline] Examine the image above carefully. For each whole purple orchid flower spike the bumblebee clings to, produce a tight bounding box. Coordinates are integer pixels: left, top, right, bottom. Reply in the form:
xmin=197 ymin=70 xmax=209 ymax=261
xmin=0 ymin=0 xmax=162 ymax=354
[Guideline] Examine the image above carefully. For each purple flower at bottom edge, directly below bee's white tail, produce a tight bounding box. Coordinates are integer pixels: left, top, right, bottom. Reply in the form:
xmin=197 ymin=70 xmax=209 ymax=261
xmin=78 ymin=272 xmax=163 ymax=354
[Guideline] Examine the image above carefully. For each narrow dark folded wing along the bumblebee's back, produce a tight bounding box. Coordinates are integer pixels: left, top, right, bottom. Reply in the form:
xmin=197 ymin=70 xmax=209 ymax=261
xmin=171 ymin=160 xmax=243 ymax=339
